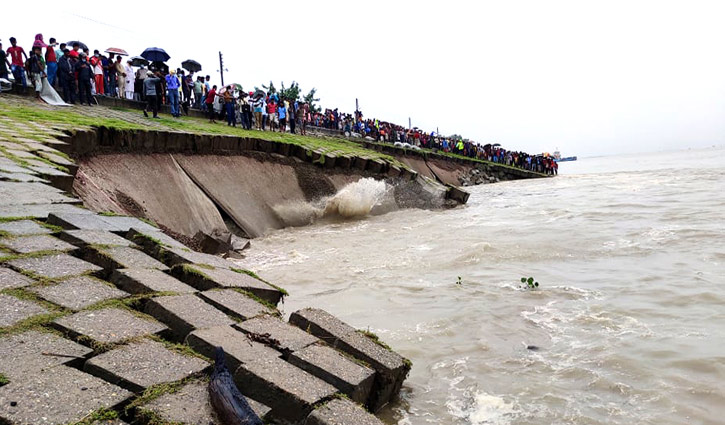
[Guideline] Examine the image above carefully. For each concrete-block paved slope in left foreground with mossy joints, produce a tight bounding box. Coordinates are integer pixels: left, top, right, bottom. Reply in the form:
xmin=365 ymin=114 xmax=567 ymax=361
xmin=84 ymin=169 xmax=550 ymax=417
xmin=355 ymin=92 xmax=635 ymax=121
xmin=0 ymin=97 xmax=411 ymax=425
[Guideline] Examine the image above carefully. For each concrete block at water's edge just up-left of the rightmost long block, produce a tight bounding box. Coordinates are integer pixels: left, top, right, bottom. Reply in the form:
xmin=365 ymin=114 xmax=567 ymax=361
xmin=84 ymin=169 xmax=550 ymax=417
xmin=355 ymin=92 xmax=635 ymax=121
xmin=171 ymin=264 xmax=282 ymax=305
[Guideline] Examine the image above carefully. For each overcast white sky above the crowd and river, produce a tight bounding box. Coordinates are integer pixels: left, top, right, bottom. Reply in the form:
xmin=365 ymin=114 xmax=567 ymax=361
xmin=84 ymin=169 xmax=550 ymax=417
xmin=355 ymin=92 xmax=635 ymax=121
xmin=0 ymin=0 xmax=725 ymax=156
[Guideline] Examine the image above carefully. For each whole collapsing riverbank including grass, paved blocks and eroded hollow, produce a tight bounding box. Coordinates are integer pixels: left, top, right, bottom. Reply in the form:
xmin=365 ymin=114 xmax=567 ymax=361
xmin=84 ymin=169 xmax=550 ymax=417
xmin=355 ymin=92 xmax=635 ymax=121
xmin=0 ymin=97 xmax=548 ymax=424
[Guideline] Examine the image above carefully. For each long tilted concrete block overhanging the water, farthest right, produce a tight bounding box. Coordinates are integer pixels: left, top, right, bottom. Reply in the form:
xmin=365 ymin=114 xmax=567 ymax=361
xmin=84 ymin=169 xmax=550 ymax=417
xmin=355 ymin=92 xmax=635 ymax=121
xmin=290 ymin=308 xmax=410 ymax=412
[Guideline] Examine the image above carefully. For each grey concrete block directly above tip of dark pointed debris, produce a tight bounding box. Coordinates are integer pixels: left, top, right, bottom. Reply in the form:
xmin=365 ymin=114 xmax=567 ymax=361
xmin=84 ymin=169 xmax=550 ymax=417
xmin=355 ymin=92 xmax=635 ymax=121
xmin=186 ymin=326 xmax=279 ymax=371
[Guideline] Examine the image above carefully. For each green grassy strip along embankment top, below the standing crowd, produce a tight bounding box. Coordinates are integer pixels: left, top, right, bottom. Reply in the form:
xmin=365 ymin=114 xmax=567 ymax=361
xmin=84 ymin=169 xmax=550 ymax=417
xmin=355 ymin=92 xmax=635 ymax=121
xmin=0 ymin=103 xmax=399 ymax=164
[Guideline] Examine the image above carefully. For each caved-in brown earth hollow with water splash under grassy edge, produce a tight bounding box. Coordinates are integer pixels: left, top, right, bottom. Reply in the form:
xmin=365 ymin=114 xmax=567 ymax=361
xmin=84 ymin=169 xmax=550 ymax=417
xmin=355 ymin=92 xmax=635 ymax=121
xmin=73 ymin=125 xmax=448 ymax=238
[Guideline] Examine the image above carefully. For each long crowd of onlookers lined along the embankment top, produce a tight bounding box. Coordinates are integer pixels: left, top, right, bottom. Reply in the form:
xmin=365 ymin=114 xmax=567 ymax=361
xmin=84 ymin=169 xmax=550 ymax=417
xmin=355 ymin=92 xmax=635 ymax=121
xmin=0 ymin=34 xmax=558 ymax=174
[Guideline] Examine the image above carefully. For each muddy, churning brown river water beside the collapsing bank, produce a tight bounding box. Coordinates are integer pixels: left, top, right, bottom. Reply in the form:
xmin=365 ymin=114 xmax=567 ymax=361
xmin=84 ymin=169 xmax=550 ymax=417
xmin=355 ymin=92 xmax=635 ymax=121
xmin=238 ymin=149 xmax=725 ymax=425
